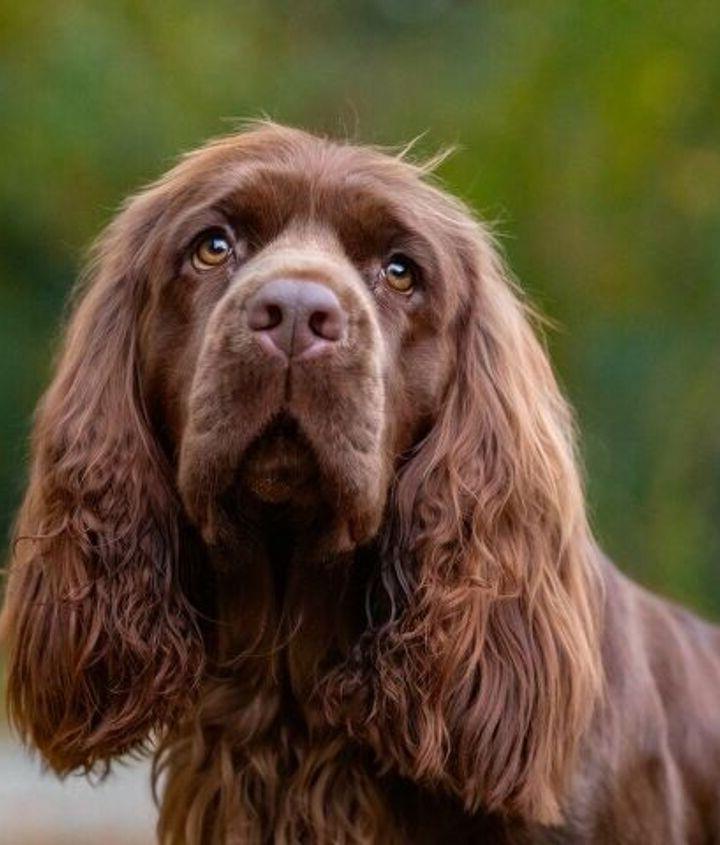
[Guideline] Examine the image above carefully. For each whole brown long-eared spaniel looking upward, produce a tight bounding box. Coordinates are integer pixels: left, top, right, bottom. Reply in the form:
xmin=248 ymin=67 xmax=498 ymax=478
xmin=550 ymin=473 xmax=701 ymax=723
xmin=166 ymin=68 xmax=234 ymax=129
xmin=5 ymin=124 xmax=720 ymax=845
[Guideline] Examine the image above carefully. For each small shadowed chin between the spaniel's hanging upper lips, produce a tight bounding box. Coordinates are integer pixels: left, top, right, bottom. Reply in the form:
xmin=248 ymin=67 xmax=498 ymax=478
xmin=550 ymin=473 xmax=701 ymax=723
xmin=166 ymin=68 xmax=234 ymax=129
xmin=238 ymin=416 xmax=322 ymax=511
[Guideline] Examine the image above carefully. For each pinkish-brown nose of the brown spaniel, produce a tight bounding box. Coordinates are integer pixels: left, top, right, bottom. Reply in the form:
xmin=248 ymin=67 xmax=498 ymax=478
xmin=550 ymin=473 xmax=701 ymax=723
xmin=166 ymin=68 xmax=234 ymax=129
xmin=247 ymin=279 xmax=347 ymax=358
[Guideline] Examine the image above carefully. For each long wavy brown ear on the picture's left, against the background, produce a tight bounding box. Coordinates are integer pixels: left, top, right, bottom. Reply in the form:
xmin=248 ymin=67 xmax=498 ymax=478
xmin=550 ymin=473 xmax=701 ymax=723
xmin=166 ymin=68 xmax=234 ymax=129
xmin=5 ymin=193 xmax=203 ymax=774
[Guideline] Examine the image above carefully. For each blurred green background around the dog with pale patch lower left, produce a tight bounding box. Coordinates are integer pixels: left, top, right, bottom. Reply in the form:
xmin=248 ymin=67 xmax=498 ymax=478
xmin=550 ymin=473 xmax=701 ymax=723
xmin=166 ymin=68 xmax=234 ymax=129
xmin=0 ymin=0 xmax=720 ymax=843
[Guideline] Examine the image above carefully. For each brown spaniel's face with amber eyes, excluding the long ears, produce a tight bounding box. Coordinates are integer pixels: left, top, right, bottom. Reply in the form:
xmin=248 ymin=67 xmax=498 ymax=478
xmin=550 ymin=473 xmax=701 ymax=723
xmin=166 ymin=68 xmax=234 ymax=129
xmin=140 ymin=130 xmax=460 ymax=553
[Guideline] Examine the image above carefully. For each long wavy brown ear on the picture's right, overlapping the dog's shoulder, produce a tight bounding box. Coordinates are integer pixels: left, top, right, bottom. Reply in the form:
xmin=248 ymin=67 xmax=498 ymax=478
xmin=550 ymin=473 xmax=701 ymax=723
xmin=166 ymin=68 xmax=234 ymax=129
xmin=329 ymin=221 xmax=601 ymax=823
